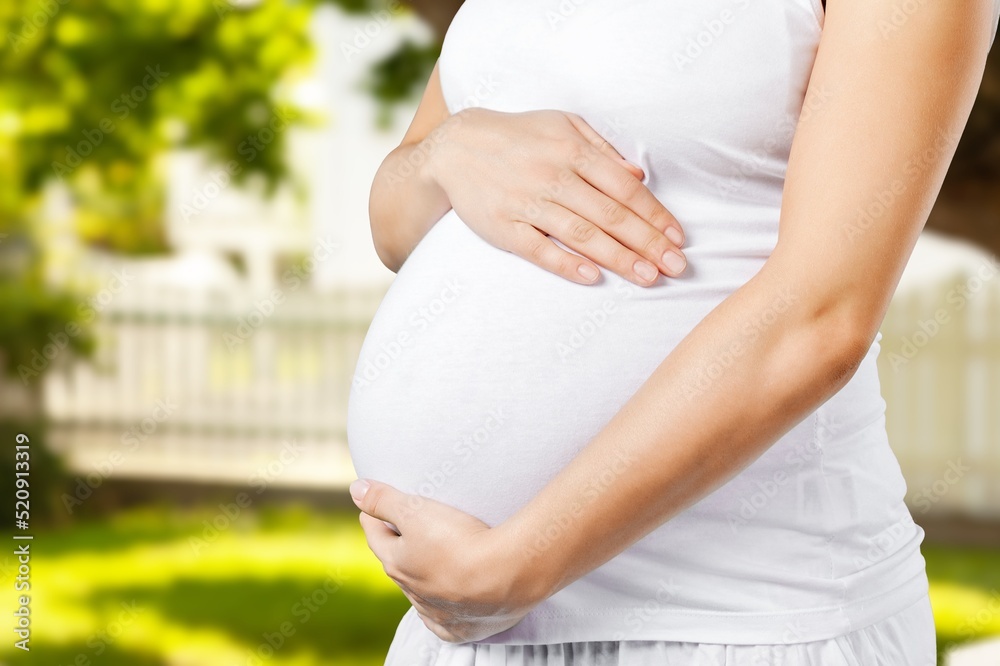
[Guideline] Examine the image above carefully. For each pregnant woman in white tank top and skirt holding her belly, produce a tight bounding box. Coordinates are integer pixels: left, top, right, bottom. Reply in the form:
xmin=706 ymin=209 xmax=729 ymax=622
xmin=348 ymin=0 xmax=1000 ymax=666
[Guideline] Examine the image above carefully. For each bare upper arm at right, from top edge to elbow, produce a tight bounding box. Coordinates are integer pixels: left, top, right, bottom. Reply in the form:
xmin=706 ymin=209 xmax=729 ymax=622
xmin=768 ymin=0 xmax=994 ymax=338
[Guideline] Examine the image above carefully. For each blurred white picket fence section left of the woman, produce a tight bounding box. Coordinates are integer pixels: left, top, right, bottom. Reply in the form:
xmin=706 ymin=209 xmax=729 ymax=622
xmin=44 ymin=285 xmax=384 ymax=487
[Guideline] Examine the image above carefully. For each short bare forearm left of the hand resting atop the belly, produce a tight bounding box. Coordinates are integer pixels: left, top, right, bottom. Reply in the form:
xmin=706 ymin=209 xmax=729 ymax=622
xmin=368 ymin=134 xmax=451 ymax=271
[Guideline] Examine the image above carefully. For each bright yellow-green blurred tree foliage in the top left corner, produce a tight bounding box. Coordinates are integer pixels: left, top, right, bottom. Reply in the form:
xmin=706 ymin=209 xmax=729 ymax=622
xmin=0 ymin=0 xmax=311 ymax=252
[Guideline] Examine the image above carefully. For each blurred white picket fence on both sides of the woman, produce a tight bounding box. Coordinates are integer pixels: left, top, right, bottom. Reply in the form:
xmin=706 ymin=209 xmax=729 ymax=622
xmin=39 ymin=258 xmax=1000 ymax=517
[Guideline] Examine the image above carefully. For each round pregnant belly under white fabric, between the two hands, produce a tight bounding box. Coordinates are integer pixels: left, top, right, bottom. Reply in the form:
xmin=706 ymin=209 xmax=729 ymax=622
xmin=348 ymin=211 xmax=764 ymax=525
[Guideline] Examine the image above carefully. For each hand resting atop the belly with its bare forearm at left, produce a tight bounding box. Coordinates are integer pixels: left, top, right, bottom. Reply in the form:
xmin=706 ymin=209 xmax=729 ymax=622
xmin=369 ymin=67 xmax=686 ymax=286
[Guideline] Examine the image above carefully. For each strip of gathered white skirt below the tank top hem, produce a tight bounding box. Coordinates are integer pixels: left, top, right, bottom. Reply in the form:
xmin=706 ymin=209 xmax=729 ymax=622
xmin=385 ymin=597 xmax=937 ymax=666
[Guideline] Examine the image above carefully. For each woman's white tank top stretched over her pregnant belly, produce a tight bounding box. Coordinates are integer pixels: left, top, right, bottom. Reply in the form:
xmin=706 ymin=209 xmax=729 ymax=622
xmin=348 ymin=0 xmax=992 ymax=644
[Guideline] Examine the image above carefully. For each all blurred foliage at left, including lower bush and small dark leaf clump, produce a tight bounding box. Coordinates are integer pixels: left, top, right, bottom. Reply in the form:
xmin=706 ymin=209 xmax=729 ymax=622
xmin=0 ymin=0 xmax=436 ymax=382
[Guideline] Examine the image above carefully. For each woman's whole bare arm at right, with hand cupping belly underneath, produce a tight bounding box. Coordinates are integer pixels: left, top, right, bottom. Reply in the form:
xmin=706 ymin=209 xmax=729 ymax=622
xmin=359 ymin=0 xmax=992 ymax=641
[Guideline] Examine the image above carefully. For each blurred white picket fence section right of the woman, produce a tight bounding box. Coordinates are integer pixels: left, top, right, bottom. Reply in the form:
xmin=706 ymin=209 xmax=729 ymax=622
xmin=879 ymin=262 xmax=1000 ymax=518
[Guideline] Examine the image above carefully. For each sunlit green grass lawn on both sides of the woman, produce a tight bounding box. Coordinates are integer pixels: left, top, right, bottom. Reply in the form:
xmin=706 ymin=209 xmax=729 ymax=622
xmin=0 ymin=509 xmax=1000 ymax=666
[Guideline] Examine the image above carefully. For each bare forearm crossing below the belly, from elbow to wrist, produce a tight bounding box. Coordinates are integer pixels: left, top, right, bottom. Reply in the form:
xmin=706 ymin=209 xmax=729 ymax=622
xmin=499 ymin=252 xmax=874 ymax=598
